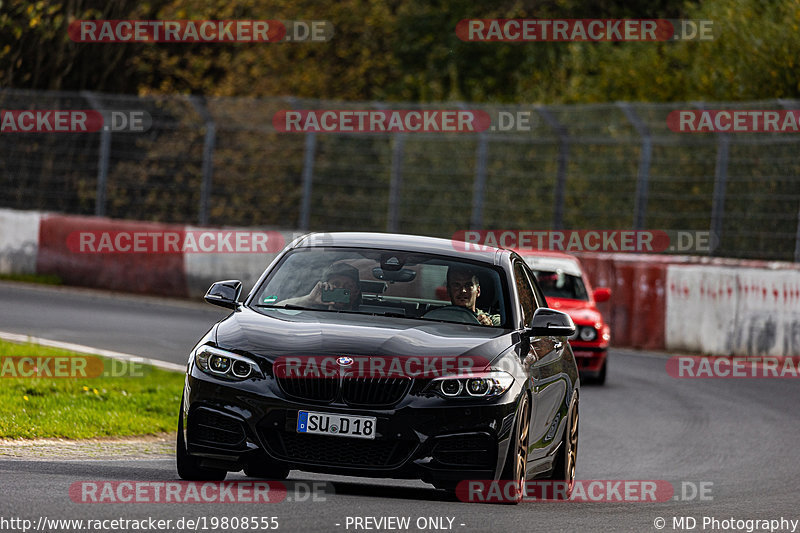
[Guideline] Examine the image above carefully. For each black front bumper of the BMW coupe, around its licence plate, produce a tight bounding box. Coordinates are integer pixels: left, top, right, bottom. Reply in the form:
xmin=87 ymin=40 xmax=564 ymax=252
xmin=183 ymin=368 xmax=520 ymax=485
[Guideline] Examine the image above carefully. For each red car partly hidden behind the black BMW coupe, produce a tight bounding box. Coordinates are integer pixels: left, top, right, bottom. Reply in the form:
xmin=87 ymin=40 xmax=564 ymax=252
xmin=517 ymin=250 xmax=611 ymax=385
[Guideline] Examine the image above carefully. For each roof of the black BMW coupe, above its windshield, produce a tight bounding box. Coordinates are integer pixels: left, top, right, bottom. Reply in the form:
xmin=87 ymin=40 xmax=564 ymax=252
xmin=289 ymin=232 xmax=511 ymax=265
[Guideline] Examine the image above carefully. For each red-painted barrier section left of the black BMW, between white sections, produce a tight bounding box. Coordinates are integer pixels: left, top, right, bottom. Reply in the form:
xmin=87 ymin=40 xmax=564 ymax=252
xmin=37 ymin=214 xmax=189 ymax=297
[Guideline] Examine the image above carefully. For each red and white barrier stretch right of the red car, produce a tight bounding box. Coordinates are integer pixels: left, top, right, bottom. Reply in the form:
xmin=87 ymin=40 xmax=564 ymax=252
xmin=578 ymin=253 xmax=800 ymax=355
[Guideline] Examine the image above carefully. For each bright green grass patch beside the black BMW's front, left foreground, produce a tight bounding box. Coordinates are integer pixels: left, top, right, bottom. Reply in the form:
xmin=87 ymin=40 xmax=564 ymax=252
xmin=0 ymin=340 xmax=184 ymax=439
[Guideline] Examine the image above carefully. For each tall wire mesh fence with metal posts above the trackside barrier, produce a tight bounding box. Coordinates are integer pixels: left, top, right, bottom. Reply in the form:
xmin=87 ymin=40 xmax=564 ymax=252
xmin=0 ymin=89 xmax=800 ymax=261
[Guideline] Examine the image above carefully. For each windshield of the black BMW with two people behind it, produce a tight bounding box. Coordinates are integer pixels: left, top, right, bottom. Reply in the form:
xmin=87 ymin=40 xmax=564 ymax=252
xmin=251 ymin=247 xmax=510 ymax=327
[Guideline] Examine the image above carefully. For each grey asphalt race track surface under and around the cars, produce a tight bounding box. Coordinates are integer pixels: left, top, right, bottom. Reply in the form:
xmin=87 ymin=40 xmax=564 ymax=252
xmin=0 ymin=283 xmax=800 ymax=532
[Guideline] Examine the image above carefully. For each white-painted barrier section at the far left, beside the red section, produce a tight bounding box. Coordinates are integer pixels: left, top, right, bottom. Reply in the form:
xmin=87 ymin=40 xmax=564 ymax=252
xmin=0 ymin=209 xmax=41 ymax=274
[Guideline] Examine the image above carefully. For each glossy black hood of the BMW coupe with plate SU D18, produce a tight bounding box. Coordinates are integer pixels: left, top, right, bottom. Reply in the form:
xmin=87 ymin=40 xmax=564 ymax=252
xmin=216 ymin=308 xmax=512 ymax=360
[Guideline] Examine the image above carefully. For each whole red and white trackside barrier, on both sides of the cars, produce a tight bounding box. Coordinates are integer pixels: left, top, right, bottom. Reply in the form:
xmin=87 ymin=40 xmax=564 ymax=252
xmin=0 ymin=209 xmax=800 ymax=355
